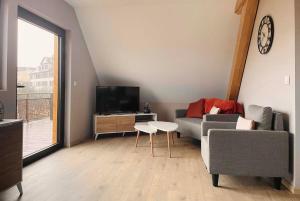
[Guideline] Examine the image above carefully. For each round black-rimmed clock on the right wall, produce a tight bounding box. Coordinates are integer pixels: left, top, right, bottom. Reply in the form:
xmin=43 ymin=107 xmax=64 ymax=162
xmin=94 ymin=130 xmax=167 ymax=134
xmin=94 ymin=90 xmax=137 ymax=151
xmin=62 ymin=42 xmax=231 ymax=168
xmin=257 ymin=15 xmax=274 ymax=54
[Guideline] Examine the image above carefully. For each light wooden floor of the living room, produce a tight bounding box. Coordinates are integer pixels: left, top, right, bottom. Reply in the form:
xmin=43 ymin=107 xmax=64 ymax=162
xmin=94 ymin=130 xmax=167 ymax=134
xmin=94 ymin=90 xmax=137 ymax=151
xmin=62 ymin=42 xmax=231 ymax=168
xmin=0 ymin=135 xmax=300 ymax=201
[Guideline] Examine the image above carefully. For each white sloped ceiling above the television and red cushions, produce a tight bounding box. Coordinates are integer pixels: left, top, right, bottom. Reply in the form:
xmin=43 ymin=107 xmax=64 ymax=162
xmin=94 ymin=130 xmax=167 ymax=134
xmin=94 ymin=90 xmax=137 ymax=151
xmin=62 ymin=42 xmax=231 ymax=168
xmin=66 ymin=0 xmax=239 ymax=103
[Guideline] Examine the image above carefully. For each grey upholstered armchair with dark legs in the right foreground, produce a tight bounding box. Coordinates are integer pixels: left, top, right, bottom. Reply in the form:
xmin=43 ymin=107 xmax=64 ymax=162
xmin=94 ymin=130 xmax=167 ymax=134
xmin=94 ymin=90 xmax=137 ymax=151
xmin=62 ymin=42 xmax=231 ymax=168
xmin=201 ymin=105 xmax=289 ymax=189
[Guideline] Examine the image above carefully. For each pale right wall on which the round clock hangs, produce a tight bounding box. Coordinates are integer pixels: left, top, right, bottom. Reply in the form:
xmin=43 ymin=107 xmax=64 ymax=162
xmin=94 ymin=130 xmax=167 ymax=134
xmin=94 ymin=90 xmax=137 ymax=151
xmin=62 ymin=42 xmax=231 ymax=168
xmin=239 ymin=0 xmax=300 ymax=187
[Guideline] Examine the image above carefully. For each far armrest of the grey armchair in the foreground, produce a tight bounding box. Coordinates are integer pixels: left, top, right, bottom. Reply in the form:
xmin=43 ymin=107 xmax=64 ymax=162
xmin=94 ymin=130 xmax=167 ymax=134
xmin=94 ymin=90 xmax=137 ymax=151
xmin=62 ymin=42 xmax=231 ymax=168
xmin=201 ymin=121 xmax=236 ymax=136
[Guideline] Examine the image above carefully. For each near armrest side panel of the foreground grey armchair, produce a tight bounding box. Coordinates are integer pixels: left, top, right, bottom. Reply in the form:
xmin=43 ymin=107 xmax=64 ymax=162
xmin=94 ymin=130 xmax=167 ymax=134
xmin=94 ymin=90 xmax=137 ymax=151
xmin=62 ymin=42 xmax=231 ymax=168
xmin=208 ymin=129 xmax=289 ymax=177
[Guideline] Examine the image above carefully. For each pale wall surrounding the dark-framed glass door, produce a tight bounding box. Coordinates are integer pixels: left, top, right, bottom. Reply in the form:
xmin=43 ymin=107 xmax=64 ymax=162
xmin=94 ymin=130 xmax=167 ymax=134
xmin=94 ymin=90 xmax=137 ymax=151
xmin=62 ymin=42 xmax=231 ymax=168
xmin=0 ymin=0 xmax=98 ymax=146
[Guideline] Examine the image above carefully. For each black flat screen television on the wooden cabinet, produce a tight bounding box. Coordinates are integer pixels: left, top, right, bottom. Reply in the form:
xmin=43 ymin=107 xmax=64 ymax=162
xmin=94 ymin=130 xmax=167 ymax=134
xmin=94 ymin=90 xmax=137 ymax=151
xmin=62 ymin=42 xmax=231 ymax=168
xmin=96 ymin=86 xmax=140 ymax=114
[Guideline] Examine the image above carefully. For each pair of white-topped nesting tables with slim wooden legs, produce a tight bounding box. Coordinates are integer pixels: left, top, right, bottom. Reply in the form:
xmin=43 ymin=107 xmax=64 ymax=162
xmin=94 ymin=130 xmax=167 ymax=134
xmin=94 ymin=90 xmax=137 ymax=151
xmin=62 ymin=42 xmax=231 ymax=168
xmin=134 ymin=121 xmax=178 ymax=158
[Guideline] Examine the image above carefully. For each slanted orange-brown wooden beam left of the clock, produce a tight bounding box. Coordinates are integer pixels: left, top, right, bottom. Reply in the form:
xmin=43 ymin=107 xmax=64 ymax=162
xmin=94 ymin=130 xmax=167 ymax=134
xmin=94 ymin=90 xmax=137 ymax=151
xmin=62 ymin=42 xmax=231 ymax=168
xmin=227 ymin=0 xmax=259 ymax=100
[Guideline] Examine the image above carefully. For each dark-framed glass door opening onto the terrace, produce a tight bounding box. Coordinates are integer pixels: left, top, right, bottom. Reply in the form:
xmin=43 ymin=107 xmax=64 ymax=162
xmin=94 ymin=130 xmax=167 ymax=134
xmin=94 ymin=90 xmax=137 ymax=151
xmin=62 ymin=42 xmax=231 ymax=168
xmin=17 ymin=7 xmax=65 ymax=164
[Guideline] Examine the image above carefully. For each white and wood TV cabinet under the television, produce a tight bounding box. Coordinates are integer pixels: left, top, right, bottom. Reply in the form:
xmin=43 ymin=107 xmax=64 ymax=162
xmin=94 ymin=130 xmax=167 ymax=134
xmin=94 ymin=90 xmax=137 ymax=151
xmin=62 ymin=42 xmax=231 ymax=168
xmin=94 ymin=113 xmax=157 ymax=140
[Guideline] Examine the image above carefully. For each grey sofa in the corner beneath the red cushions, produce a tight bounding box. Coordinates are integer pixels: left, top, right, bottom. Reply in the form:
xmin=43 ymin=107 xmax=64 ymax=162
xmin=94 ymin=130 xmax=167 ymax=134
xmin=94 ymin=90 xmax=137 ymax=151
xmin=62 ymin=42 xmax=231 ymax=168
xmin=175 ymin=109 xmax=239 ymax=140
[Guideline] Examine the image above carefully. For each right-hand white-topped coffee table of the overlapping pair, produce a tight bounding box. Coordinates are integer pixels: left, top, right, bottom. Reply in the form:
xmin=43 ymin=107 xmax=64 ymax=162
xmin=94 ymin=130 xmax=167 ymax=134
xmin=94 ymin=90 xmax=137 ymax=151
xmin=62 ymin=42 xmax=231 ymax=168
xmin=148 ymin=121 xmax=178 ymax=158
